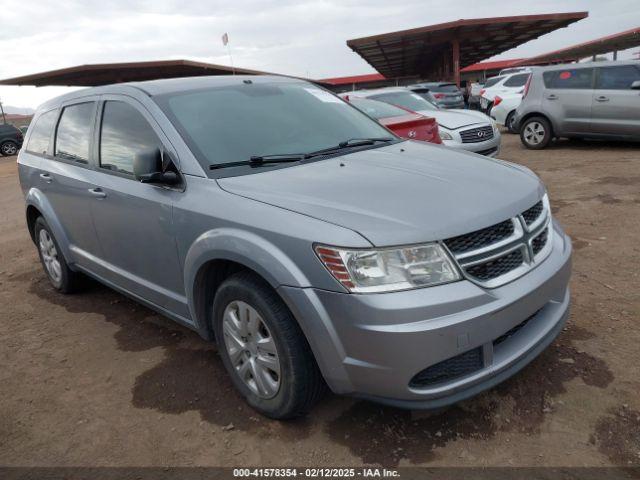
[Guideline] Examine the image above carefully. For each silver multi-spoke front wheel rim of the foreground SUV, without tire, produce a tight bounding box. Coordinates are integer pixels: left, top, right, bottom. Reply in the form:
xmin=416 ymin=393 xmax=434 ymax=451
xmin=222 ymin=300 xmax=281 ymax=399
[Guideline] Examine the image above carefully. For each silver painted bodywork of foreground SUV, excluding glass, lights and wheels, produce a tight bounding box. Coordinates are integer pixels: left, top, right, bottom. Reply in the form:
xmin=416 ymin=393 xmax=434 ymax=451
xmin=18 ymin=76 xmax=571 ymax=407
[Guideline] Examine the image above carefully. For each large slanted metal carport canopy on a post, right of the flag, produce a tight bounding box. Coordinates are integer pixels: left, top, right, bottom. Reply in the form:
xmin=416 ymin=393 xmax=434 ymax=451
xmin=347 ymin=12 xmax=589 ymax=81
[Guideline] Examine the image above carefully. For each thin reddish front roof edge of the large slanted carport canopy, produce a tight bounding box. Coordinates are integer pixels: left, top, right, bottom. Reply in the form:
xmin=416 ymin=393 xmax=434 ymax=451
xmin=347 ymin=11 xmax=589 ymax=49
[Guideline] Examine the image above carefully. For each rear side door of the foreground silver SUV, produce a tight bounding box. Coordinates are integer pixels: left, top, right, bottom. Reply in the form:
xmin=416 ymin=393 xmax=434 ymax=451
xmin=37 ymin=97 xmax=101 ymax=267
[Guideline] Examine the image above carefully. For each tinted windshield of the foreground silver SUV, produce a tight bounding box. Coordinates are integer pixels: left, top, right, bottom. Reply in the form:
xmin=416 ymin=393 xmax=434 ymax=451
xmin=156 ymin=80 xmax=395 ymax=167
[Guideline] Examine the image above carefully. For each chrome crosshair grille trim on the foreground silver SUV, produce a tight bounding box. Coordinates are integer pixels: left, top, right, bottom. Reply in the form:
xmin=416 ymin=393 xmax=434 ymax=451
xmin=442 ymin=195 xmax=553 ymax=288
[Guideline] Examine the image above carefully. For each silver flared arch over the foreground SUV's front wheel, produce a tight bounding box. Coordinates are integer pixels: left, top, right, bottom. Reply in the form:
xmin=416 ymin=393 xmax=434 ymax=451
xmin=184 ymin=228 xmax=310 ymax=330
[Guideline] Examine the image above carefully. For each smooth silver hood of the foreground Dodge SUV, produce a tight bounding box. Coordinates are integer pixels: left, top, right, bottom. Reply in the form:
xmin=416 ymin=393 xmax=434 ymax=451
xmin=218 ymin=141 xmax=544 ymax=246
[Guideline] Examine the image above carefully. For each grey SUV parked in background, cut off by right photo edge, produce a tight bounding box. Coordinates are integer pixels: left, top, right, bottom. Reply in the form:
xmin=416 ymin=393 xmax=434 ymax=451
xmin=515 ymin=60 xmax=640 ymax=150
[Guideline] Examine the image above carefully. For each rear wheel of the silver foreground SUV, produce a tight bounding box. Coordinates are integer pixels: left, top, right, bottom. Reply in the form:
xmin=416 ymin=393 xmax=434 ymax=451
xmin=34 ymin=217 xmax=81 ymax=293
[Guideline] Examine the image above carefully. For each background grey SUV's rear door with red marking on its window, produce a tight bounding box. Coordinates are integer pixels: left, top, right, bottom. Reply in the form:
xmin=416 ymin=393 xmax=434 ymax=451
xmin=541 ymin=68 xmax=594 ymax=135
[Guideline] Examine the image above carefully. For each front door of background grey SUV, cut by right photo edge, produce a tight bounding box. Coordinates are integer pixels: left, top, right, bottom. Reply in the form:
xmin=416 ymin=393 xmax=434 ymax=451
xmin=591 ymin=65 xmax=640 ymax=138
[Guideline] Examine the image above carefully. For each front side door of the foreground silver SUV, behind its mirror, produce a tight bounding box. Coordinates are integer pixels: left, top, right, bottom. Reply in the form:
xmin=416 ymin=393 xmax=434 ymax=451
xmin=86 ymin=95 xmax=188 ymax=316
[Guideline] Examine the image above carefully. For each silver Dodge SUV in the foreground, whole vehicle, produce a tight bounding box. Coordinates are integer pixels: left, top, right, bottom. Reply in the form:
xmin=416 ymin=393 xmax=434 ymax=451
xmin=18 ymin=76 xmax=571 ymax=418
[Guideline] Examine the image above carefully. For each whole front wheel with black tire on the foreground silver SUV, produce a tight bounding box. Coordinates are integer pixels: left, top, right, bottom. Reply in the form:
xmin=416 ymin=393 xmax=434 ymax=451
xmin=212 ymin=272 xmax=326 ymax=420
